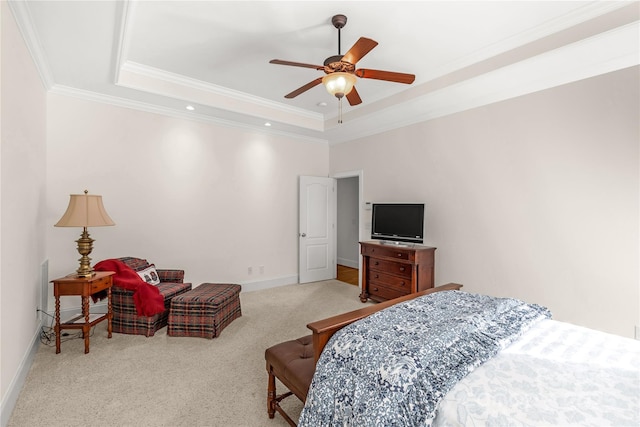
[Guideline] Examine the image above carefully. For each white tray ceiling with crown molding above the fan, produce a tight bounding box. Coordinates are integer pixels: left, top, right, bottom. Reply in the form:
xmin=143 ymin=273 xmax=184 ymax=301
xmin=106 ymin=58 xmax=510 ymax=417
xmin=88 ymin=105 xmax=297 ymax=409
xmin=9 ymin=0 xmax=640 ymax=143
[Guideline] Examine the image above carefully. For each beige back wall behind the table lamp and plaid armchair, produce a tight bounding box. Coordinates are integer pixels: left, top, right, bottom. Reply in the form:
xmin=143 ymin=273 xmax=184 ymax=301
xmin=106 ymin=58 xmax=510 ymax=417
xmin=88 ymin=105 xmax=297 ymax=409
xmin=47 ymin=94 xmax=329 ymax=302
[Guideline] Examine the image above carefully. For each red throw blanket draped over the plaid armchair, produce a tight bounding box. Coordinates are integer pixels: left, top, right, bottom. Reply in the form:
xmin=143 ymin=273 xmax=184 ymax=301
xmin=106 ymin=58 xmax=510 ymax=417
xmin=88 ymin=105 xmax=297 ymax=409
xmin=93 ymin=259 xmax=164 ymax=316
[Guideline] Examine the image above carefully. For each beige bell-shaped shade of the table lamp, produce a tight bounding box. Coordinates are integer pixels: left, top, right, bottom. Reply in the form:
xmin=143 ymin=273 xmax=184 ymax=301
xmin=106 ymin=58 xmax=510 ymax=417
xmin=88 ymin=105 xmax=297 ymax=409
xmin=55 ymin=191 xmax=115 ymax=227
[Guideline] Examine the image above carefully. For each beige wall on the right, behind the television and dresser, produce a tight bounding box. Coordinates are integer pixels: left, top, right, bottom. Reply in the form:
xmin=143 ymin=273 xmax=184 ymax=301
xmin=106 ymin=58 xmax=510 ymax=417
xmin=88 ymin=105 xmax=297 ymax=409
xmin=330 ymin=67 xmax=640 ymax=337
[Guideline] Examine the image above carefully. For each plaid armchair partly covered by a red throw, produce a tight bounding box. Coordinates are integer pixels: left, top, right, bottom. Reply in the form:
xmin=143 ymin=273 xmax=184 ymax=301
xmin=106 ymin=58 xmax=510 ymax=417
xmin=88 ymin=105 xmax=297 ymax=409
xmin=111 ymin=257 xmax=191 ymax=337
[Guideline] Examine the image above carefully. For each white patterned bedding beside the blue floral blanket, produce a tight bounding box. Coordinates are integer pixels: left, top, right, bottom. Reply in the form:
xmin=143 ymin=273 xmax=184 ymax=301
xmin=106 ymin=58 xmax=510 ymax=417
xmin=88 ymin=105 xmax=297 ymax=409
xmin=433 ymin=320 xmax=640 ymax=427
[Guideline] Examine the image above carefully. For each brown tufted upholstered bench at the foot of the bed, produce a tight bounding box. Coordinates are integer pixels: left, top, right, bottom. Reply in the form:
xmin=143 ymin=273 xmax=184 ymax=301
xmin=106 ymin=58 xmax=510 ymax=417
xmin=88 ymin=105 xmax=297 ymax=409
xmin=264 ymin=335 xmax=316 ymax=426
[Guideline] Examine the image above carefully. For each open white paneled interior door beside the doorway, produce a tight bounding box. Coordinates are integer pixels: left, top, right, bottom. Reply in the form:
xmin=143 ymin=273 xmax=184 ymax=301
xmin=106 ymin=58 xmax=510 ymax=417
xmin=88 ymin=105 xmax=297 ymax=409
xmin=298 ymin=176 xmax=336 ymax=283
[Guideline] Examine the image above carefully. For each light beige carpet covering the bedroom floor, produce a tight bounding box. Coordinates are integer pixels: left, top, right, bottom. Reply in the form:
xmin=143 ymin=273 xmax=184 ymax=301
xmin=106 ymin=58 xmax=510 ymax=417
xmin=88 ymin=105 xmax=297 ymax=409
xmin=9 ymin=280 xmax=370 ymax=427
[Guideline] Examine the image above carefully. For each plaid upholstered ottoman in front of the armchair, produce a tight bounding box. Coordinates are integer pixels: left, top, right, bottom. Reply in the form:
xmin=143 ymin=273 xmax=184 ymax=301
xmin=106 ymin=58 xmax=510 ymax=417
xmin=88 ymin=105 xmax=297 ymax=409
xmin=167 ymin=283 xmax=242 ymax=339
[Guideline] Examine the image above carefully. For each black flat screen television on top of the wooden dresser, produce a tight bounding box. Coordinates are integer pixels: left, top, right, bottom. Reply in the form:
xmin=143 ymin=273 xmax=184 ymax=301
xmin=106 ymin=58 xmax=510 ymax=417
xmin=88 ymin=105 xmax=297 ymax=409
xmin=371 ymin=203 xmax=424 ymax=243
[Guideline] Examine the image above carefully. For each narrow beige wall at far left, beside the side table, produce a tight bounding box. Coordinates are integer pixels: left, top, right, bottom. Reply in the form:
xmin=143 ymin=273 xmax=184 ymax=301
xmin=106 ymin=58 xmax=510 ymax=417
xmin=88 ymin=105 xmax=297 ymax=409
xmin=0 ymin=1 xmax=46 ymax=423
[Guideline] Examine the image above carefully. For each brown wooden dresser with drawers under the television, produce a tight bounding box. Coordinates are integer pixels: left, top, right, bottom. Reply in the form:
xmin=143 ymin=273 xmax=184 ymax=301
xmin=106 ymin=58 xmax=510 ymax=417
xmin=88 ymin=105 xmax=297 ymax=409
xmin=360 ymin=241 xmax=436 ymax=302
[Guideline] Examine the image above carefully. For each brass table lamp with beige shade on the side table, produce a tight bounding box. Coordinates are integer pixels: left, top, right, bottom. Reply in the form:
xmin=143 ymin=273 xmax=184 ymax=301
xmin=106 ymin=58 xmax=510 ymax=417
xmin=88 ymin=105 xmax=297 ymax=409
xmin=54 ymin=190 xmax=115 ymax=277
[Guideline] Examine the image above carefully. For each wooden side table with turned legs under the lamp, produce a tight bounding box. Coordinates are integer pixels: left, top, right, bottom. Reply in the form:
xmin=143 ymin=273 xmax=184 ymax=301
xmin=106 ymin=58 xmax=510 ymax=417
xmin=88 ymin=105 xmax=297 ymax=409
xmin=51 ymin=271 xmax=115 ymax=354
